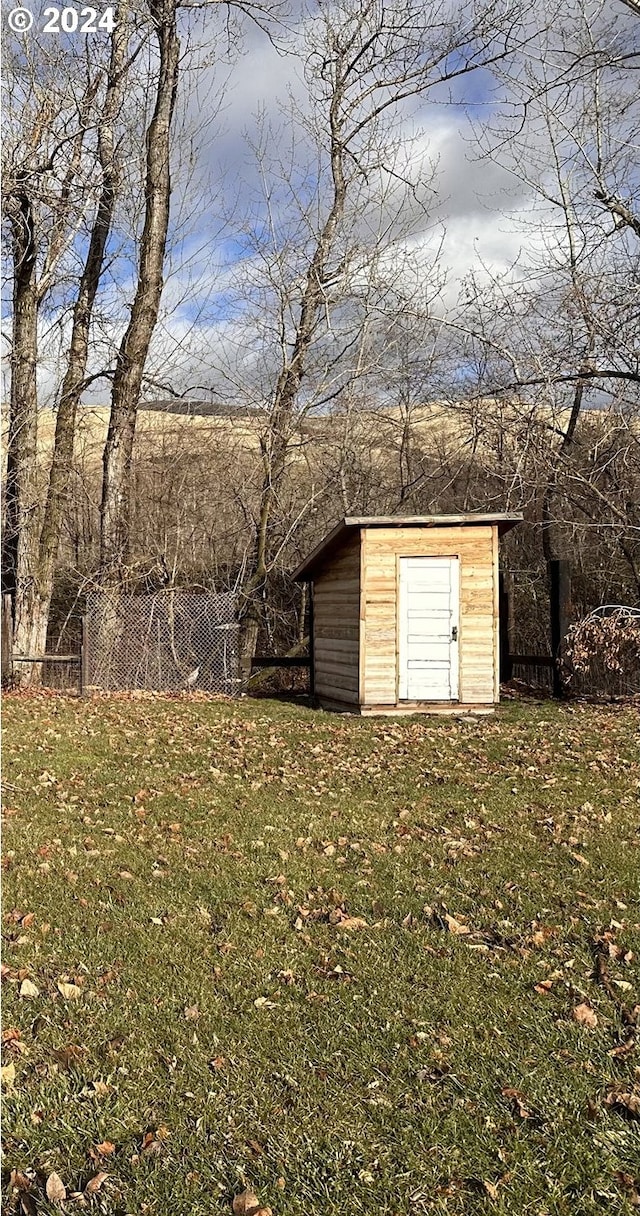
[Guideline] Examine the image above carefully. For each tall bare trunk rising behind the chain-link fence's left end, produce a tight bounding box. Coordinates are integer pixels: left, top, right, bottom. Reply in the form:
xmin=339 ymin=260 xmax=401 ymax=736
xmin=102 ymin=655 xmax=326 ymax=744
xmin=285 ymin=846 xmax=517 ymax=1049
xmin=100 ymin=0 xmax=180 ymax=586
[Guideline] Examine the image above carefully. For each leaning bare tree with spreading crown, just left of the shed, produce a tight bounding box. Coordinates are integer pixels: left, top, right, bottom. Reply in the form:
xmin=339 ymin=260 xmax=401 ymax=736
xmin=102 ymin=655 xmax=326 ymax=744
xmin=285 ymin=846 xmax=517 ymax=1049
xmin=210 ymin=0 xmax=532 ymax=653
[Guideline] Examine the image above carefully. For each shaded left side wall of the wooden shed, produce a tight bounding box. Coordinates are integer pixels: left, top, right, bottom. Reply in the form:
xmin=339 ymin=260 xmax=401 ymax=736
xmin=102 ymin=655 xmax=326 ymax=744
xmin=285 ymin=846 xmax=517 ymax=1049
xmin=313 ymin=533 xmax=360 ymax=704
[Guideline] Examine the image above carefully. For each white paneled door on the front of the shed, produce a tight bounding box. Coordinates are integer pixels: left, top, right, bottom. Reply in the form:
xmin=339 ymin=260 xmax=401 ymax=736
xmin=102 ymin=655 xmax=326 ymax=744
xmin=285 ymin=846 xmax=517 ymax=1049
xmin=398 ymin=557 xmax=460 ymax=700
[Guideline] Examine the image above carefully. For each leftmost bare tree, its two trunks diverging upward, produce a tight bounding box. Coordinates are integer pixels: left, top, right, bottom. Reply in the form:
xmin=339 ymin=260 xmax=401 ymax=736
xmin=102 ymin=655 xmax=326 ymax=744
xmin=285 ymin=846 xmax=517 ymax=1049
xmin=4 ymin=30 xmax=133 ymax=682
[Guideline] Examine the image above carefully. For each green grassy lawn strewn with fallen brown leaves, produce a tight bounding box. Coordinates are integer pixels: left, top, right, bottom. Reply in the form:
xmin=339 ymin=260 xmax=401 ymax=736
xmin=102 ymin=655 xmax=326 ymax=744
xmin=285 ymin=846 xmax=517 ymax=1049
xmin=2 ymin=696 xmax=640 ymax=1216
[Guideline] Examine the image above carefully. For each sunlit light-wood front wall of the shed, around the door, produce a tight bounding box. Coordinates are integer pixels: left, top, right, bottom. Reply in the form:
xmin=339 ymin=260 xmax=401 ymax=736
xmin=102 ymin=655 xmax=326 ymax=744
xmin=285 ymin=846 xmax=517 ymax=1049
xmin=361 ymin=524 xmax=499 ymax=705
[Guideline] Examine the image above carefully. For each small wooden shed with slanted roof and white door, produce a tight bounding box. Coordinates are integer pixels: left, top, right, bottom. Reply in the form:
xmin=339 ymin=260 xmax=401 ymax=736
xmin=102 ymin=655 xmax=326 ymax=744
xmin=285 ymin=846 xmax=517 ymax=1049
xmin=293 ymin=514 xmax=522 ymax=714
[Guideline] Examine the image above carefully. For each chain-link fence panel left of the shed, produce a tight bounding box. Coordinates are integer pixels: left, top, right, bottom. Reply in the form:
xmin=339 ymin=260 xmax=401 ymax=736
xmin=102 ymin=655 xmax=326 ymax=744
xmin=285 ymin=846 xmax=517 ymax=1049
xmin=83 ymin=591 xmax=241 ymax=696
